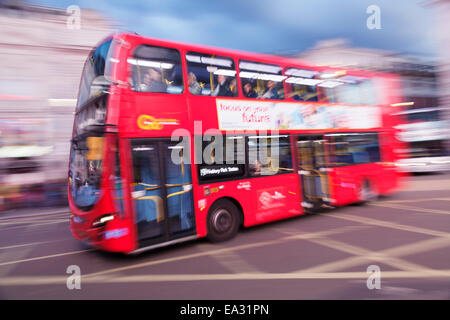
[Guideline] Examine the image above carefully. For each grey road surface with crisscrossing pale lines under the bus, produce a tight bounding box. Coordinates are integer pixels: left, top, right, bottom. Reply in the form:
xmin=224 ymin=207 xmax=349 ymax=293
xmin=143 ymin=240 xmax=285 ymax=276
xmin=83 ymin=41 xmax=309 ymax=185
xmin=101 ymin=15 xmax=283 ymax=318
xmin=0 ymin=174 xmax=450 ymax=300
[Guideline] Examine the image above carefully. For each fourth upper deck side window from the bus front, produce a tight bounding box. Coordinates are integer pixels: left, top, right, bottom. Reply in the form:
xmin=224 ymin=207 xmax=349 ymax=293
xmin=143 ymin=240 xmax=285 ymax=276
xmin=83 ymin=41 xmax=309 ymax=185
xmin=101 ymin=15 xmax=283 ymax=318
xmin=284 ymin=68 xmax=321 ymax=101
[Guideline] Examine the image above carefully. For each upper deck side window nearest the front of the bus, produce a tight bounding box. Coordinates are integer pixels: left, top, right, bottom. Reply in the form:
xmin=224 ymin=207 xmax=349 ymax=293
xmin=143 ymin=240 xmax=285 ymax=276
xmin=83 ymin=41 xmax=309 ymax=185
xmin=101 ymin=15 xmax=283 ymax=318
xmin=127 ymin=45 xmax=183 ymax=93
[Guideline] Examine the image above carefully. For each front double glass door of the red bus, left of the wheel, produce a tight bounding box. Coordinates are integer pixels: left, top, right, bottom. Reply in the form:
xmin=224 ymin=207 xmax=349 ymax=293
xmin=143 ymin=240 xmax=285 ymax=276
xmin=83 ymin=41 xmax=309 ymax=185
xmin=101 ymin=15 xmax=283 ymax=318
xmin=131 ymin=139 xmax=195 ymax=248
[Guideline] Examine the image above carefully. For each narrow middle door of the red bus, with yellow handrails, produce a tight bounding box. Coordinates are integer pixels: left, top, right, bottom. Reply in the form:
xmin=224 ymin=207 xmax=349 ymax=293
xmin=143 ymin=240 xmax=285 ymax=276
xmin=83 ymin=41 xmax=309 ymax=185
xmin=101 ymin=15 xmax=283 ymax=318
xmin=296 ymin=136 xmax=329 ymax=211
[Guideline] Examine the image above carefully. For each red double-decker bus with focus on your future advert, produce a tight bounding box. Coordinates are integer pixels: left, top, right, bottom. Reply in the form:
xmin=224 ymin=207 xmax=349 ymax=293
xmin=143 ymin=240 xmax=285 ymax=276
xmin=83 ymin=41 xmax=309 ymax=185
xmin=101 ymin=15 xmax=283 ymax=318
xmin=68 ymin=34 xmax=399 ymax=253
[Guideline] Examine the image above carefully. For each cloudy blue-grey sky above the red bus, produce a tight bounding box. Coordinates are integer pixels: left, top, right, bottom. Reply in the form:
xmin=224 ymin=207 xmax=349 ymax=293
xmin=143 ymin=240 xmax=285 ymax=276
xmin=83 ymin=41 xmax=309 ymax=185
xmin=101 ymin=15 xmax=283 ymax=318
xmin=34 ymin=0 xmax=436 ymax=56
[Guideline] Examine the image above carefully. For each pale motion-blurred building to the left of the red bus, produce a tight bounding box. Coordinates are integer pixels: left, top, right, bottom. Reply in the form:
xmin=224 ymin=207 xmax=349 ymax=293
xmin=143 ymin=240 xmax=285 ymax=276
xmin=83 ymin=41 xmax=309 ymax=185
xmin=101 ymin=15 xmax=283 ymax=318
xmin=0 ymin=0 xmax=113 ymax=210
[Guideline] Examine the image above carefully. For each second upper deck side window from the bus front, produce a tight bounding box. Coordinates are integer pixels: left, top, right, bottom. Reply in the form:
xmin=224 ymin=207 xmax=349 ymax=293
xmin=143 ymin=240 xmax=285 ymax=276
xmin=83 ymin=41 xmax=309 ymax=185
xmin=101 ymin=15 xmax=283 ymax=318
xmin=186 ymin=52 xmax=238 ymax=97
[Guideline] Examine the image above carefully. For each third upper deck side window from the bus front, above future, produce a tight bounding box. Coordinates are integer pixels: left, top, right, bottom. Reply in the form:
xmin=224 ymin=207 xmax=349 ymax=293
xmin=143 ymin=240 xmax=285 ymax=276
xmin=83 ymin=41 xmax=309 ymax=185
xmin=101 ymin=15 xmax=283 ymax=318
xmin=239 ymin=60 xmax=286 ymax=99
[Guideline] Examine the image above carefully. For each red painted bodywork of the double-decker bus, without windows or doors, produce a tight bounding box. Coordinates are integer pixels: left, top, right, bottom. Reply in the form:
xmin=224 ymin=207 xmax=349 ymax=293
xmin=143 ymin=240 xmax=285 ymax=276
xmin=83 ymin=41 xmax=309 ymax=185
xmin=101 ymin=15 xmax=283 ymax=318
xmin=69 ymin=34 xmax=400 ymax=253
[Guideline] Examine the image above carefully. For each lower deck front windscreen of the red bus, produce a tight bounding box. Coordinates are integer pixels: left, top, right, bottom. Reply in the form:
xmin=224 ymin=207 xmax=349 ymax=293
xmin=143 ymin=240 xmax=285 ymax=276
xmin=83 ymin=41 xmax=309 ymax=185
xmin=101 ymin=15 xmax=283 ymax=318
xmin=69 ymin=136 xmax=104 ymax=211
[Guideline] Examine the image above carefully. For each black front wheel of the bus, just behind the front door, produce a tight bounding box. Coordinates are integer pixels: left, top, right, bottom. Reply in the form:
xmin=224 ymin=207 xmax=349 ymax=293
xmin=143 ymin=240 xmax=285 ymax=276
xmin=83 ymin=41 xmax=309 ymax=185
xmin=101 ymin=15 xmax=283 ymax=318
xmin=207 ymin=199 xmax=241 ymax=242
